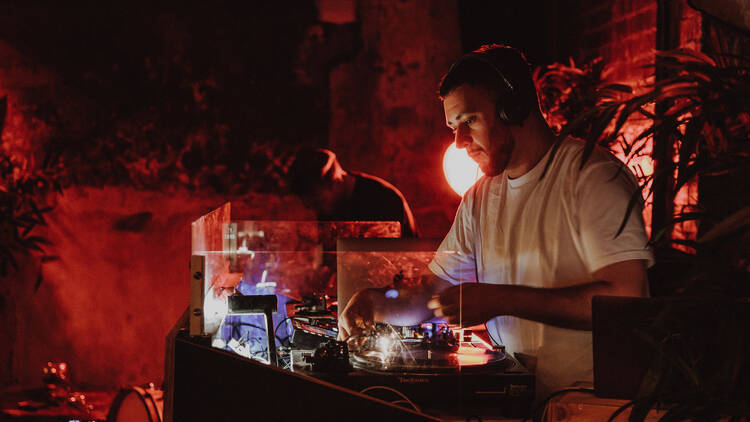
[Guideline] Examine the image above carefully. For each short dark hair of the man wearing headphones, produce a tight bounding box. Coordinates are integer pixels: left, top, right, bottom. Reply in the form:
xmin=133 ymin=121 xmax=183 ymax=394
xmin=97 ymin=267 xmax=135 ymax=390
xmin=438 ymin=44 xmax=539 ymax=113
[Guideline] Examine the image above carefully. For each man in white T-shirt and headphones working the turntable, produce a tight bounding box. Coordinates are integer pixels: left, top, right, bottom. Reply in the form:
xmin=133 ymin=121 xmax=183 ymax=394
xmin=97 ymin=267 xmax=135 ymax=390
xmin=339 ymin=45 xmax=653 ymax=398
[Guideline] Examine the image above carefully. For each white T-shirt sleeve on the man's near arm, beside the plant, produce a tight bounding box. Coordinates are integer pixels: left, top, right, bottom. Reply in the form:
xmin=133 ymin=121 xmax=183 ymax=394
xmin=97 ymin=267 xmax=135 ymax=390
xmin=576 ymin=158 xmax=654 ymax=273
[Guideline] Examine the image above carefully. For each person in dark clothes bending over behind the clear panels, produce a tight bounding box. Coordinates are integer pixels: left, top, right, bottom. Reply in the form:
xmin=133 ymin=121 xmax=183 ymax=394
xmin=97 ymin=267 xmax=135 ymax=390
xmin=289 ymin=148 xmax=418 ymax=237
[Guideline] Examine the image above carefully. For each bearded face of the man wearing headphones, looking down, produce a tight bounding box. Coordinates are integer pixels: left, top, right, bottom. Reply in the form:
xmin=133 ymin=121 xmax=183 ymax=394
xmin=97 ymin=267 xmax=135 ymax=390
xmin=443 ymin=85 xmax=515 ymax=176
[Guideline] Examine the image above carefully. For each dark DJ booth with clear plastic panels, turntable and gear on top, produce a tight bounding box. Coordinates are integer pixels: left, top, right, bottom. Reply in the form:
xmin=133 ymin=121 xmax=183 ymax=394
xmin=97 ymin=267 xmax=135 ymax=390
xmin=164 ymin=203 xmax=534 ymax=421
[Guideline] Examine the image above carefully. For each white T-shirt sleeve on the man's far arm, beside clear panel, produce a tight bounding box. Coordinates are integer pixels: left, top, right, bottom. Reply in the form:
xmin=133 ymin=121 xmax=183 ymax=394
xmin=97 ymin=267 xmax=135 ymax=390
xmin=428 ymin=189 xmax=477 ymax=284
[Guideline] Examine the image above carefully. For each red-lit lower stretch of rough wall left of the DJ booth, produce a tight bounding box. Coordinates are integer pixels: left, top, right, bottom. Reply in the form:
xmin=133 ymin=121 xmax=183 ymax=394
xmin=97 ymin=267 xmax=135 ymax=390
xmin=11 ymin=188 xmax=308 ymax=387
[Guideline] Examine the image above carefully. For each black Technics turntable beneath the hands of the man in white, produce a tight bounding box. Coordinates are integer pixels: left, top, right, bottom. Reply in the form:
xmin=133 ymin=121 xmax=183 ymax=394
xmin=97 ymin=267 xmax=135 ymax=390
xmin=292 ymin=323 xmax=534 ymax=417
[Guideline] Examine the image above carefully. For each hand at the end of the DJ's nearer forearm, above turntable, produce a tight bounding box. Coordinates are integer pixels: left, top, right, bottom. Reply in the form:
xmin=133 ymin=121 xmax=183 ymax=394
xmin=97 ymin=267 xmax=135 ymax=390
xmin=427 ymin=283 xmax=501 ymax=327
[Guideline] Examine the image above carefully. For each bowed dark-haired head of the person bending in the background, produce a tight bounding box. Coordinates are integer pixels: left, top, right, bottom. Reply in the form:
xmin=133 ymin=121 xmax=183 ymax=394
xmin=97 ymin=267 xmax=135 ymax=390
xmin=287 ymin=148 xmax=345 ymax=195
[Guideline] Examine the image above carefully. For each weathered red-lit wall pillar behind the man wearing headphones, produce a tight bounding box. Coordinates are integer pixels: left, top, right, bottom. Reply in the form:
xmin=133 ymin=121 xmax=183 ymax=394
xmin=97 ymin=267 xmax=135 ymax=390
xmin=329 ymin=0 xmax=461 ymax=237
